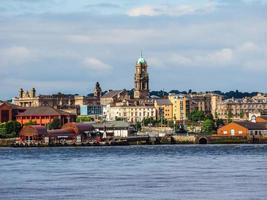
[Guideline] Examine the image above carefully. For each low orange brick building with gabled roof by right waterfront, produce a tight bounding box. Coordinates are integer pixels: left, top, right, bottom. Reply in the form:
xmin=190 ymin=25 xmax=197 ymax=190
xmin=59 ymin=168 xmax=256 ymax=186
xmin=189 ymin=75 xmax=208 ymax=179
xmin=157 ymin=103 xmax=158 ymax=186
xmin=217 ymin=121 xmax=267 ymax=136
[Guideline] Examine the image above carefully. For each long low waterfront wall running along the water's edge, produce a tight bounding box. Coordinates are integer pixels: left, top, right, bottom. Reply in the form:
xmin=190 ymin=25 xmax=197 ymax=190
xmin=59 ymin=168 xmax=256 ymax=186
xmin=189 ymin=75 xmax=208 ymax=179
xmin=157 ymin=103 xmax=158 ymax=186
xmin=0 ymin=135 xmax=267 ymax=148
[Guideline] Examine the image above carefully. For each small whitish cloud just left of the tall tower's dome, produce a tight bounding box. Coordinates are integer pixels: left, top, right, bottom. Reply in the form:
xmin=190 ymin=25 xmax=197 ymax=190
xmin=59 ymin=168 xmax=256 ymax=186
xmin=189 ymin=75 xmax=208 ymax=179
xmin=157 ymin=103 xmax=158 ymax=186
xmin=83 ymin=57 xmax=112 ymax=72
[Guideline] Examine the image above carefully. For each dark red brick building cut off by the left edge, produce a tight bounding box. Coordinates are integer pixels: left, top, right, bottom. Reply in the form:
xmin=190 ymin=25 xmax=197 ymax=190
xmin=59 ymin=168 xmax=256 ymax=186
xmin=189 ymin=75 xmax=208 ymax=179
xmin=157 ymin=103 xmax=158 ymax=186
xmin=0 ymin=102 xmax=26 ymax=123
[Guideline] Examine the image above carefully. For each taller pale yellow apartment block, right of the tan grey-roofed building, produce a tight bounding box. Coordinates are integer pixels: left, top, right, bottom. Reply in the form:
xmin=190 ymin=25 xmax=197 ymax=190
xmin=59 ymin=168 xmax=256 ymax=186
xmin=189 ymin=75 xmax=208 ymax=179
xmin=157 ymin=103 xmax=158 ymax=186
xmin=169 ymin=94 xmax=191 ymax=121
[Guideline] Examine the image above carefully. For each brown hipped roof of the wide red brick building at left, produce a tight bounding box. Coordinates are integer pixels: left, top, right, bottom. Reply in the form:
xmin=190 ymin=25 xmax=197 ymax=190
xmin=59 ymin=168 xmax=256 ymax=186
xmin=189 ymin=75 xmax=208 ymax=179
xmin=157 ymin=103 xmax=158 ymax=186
xmin=18 ymin=106 xmax=73 ymax=116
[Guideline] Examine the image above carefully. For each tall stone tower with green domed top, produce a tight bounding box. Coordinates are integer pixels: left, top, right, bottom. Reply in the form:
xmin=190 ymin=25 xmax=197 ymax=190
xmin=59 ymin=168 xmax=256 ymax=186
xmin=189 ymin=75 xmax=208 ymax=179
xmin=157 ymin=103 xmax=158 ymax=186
xmin=134 ymin=53 xmax=149 ymax=99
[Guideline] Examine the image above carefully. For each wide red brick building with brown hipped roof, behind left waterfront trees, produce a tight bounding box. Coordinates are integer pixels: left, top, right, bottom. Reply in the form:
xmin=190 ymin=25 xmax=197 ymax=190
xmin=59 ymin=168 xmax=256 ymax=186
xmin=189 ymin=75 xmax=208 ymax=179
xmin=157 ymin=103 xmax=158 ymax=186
xmin=16 ymin=106 xmax=76 ymax=125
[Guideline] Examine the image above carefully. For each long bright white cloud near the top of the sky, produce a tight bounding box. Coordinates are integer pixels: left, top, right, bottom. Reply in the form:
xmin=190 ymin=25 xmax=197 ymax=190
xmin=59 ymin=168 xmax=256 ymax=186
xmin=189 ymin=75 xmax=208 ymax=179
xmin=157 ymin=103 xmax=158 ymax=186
xmin=127 ymin=2 xmax=215 ymax=17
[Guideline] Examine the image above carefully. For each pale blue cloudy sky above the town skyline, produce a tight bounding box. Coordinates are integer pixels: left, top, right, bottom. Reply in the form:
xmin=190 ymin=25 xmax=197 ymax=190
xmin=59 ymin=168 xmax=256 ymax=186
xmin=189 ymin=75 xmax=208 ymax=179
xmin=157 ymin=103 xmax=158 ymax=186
xmin=0 ymin=0 xmax=267 ymax=100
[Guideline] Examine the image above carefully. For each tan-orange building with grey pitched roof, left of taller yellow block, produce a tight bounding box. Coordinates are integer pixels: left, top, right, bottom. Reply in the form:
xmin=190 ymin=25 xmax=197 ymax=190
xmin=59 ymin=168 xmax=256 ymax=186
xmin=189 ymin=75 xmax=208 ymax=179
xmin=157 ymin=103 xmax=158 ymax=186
xmin=154 ymin=99 xmax=173 ymax=120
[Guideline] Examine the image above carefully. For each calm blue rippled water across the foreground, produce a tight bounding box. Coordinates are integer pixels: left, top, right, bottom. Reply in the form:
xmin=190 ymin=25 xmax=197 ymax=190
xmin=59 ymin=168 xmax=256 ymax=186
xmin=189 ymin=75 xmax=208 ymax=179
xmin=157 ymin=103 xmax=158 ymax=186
xmin=0 ymin=145 xmax=267 ymax=200
